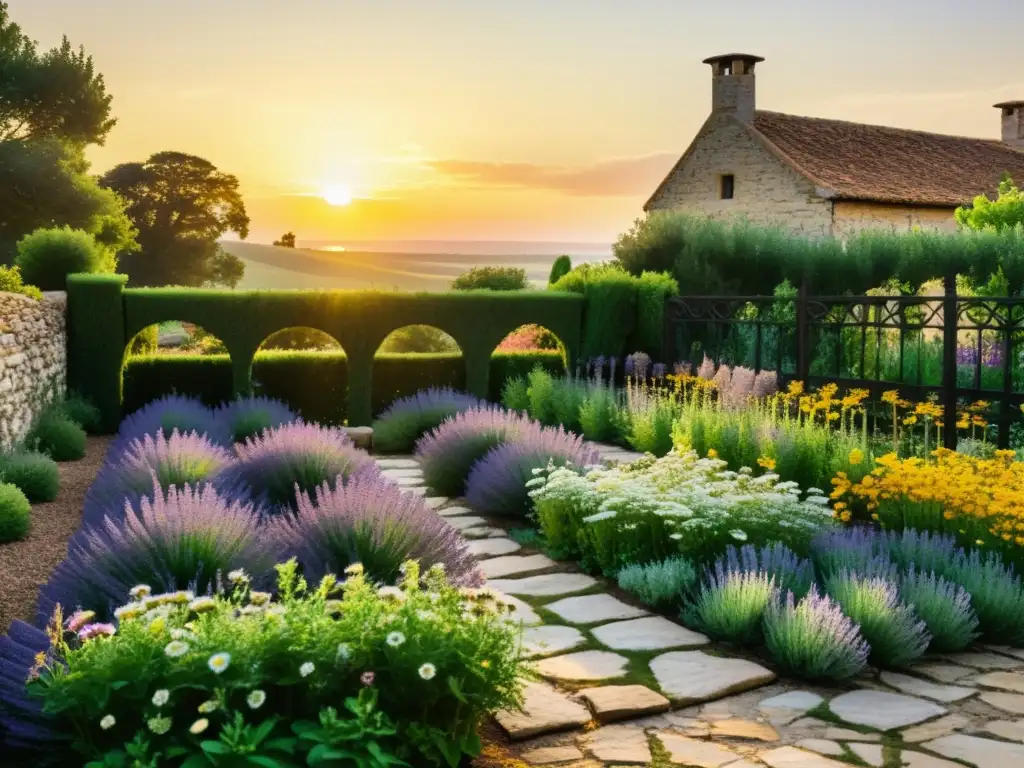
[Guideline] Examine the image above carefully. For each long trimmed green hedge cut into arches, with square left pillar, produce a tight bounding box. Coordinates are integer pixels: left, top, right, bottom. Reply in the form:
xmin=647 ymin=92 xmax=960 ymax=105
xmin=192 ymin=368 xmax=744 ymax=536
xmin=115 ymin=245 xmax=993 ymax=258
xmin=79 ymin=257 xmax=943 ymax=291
xmin=68 ymin=275 xmax=584 ymax=429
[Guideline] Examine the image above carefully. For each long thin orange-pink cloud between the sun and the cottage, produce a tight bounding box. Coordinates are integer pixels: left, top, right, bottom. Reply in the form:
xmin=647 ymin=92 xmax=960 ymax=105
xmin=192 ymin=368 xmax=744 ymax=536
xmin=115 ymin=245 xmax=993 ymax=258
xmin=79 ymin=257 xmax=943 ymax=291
xmin=426 ymin=153 xmax=679 ymax=197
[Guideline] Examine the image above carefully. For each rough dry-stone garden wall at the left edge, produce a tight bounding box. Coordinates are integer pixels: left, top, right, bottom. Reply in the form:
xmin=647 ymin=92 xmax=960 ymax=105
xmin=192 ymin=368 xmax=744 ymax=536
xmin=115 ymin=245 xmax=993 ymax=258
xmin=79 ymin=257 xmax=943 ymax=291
xmin=0 ymin=293 xmax=68 ymax=449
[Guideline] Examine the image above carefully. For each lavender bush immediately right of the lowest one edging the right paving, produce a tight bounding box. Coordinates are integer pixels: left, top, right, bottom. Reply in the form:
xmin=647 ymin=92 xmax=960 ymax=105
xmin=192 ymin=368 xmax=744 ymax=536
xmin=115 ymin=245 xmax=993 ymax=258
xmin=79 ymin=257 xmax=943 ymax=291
xmin=825 ymin=569 xmax=932 ymax=667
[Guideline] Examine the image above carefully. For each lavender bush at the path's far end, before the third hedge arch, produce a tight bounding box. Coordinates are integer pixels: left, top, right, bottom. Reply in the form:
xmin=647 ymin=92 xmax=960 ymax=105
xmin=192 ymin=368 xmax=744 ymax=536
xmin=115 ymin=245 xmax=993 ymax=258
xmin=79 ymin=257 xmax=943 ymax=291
xmin=374 ymin=387 xmax=485 ymax=454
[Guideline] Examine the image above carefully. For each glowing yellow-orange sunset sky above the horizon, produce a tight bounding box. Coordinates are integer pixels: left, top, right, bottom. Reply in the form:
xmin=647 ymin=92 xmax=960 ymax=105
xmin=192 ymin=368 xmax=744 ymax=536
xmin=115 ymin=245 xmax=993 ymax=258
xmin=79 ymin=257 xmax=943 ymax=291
xmin=9 ymin=0 xmax=1024 ymax=242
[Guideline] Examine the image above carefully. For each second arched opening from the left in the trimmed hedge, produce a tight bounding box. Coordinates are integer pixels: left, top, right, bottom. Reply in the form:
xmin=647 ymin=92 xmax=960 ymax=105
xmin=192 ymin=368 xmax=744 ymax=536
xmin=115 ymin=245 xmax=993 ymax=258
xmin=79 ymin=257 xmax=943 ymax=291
xmin=250 ymin=326 xmax=348 ymax=424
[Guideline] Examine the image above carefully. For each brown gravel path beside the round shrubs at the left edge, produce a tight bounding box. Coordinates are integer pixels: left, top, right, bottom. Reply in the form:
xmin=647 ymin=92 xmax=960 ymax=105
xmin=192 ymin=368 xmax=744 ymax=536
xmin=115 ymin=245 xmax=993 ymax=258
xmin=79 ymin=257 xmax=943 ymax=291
xmin=0 ymin=437 xmax=111 ymax=634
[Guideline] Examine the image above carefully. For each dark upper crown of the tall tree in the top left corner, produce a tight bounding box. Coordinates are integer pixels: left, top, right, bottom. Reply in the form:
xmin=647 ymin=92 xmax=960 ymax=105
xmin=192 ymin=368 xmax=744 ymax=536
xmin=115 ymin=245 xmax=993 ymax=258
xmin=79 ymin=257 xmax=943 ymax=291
xmin=0 ymin=0 xmax=116 ymax=145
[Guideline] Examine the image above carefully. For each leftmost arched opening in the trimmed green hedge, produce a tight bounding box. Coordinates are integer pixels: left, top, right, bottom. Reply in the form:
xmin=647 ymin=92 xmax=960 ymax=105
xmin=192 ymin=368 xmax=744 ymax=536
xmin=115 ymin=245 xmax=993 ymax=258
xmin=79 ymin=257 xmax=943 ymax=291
xmin=121 ymin=319 xmax=232 ymax=414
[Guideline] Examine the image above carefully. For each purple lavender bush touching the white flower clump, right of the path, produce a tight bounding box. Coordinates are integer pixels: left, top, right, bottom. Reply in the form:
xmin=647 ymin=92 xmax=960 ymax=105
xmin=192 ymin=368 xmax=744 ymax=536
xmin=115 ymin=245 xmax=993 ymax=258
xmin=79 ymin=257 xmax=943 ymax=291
xmin=466 ymin=424 xmax=601 ymax=517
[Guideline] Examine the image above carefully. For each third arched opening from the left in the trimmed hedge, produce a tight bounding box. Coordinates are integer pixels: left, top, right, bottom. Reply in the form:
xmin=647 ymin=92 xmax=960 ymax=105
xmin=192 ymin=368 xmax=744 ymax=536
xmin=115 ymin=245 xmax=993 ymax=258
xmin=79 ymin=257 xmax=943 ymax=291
xmin=372 ymin=325 xmax=466 ymax=414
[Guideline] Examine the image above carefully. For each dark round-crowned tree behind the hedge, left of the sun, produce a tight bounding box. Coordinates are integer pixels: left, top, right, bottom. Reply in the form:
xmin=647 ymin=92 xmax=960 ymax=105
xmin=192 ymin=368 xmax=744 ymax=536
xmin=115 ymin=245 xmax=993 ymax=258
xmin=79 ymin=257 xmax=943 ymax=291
xmin=100 ymin=152 xmax=249 ymax=287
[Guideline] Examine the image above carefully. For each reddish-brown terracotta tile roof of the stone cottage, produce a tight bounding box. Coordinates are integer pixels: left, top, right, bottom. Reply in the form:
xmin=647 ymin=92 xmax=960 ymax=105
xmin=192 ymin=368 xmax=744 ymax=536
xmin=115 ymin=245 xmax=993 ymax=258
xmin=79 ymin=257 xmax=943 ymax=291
xmin=754 ymin=111 xmax=1024 ymax=206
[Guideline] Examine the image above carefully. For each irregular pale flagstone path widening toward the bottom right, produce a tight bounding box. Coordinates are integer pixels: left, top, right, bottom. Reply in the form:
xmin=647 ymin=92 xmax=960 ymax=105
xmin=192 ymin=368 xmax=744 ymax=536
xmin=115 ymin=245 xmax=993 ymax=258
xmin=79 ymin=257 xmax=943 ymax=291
xmin=378 ymin=446 xmax=1024 ymax=768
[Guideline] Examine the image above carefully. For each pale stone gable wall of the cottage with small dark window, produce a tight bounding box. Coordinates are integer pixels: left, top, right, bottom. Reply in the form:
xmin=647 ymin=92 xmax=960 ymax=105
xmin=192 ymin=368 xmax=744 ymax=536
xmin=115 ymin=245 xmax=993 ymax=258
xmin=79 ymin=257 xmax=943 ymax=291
xmin=648 ymin=115 xmax=831 ymax=237
